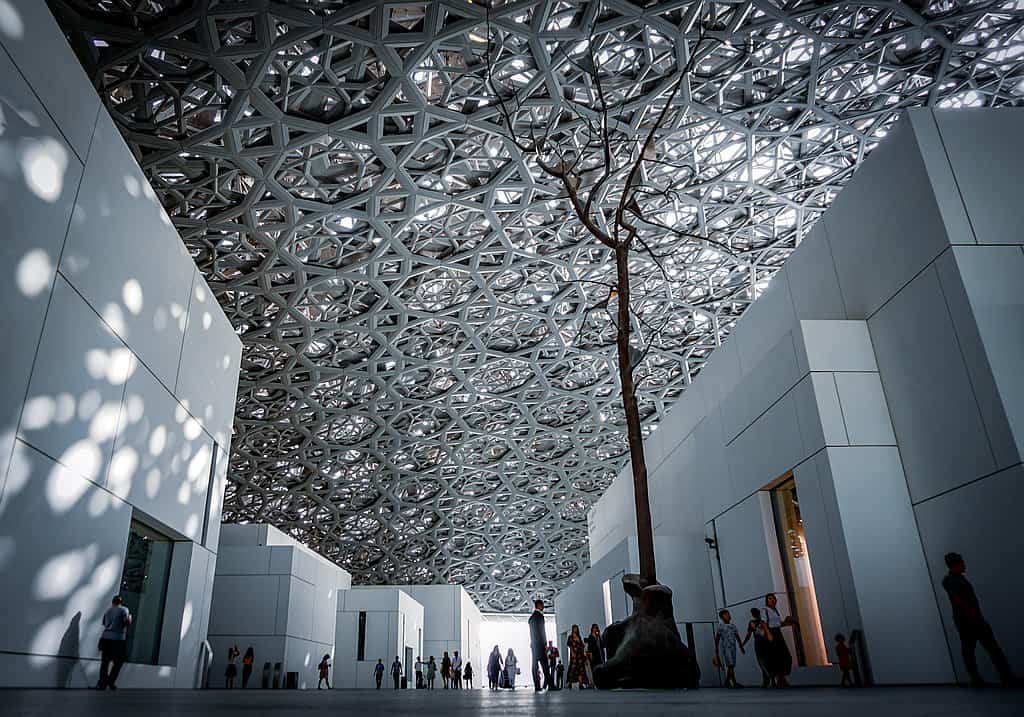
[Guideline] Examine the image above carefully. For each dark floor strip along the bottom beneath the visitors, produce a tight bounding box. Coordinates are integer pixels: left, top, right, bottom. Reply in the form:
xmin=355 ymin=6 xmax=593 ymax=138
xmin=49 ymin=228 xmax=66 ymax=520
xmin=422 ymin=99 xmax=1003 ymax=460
xmin=0 ymin=687 xmax=1024 ymax=717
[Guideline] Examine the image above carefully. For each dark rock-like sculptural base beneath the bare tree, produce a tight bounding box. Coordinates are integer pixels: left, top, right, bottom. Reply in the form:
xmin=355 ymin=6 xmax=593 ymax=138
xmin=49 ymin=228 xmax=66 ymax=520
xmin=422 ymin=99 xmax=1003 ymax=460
xmin=594 ymin=575 xmax=700 ymax=689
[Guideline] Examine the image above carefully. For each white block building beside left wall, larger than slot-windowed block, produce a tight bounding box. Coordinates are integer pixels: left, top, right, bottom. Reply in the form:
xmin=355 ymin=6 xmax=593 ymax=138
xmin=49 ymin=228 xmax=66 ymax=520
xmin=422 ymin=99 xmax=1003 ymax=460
xmin=209 ymin=524 xmax=352 ymax=689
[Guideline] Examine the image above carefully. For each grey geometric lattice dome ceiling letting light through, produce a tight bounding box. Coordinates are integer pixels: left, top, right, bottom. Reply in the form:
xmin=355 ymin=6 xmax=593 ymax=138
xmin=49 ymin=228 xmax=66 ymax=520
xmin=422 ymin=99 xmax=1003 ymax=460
xmin=49 ymin=0 xmax=1024 ymax=610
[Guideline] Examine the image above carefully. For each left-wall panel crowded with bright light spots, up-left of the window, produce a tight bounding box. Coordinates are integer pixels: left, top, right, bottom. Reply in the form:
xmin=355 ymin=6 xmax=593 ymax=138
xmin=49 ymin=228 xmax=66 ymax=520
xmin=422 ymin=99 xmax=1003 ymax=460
xmin=18 ymin=278 xmax=136 ymax=483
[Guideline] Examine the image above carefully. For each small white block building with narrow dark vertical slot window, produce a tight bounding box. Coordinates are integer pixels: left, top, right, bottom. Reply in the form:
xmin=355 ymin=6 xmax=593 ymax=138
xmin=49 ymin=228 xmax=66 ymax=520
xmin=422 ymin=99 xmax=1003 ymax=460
xmin=333 ymin=586 xmax=424 ymax=688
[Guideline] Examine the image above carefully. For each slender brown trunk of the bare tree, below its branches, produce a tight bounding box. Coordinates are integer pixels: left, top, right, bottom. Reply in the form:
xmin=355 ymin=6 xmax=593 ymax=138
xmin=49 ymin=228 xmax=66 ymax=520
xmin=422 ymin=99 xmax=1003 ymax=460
xmin=615 ymin=246 xmax=657 ymax=584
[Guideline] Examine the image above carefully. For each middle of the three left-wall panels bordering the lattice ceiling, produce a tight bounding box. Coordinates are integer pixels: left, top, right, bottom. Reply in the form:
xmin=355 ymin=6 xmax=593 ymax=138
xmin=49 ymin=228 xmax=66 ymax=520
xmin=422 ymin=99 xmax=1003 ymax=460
xmin=60 ymin=112 xmax=196 ymax=388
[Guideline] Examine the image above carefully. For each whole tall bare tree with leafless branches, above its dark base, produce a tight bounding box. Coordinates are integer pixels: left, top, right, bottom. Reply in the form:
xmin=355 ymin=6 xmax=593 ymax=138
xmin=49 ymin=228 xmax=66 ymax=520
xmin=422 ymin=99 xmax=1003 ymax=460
xmin=485 ymin=2 xmax=733 ymax=585
